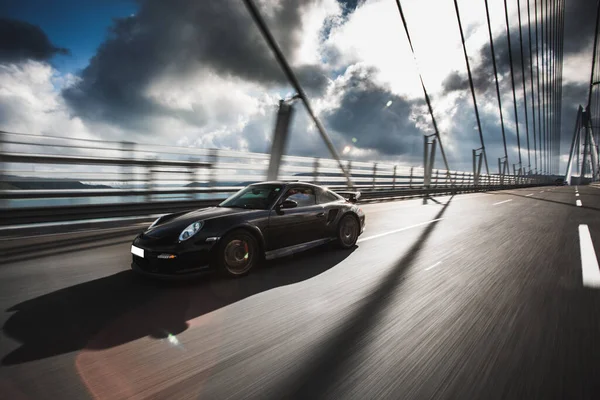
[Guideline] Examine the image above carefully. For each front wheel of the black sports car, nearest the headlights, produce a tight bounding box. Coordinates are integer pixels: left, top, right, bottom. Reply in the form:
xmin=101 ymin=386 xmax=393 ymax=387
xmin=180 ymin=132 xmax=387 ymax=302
xmin=216 ymin=229 xmax=261 ymax=278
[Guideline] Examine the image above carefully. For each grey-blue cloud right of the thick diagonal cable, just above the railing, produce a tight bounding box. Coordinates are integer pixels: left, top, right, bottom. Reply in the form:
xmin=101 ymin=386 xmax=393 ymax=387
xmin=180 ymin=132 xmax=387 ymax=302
xmin=324 ymin=65 xmax=423 ymax=155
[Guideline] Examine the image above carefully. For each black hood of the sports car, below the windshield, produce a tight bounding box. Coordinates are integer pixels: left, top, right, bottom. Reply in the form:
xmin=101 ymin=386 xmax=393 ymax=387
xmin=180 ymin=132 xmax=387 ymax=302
xmin=144 ymin=207 xmax=263 ymax=238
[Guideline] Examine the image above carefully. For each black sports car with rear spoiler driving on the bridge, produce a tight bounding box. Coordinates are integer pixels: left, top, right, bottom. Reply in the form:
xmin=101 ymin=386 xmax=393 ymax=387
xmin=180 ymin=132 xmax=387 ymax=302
xmin=131 ymin=182 xmax=365 ymax=277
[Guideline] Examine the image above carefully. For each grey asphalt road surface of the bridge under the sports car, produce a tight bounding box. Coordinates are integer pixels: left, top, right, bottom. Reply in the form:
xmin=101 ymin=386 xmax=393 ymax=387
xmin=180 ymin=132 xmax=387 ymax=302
xmin=0 ymin=186 xmax=600 ymax=400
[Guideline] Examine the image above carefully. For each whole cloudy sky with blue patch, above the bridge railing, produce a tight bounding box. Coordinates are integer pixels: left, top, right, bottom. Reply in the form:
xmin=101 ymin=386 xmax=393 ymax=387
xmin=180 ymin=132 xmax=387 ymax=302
xmin=0 ymin=0 xmax=595 ymax=172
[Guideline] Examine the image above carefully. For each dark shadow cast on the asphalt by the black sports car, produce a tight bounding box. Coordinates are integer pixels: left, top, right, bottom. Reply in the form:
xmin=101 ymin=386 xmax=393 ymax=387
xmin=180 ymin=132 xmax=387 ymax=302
xmin=2 ymin=244 xmax=356 ymax=365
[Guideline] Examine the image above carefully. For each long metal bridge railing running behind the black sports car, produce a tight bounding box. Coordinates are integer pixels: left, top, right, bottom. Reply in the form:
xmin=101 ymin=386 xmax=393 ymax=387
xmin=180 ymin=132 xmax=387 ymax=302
xmin=0 ymin=132 xmax=548 ymax=225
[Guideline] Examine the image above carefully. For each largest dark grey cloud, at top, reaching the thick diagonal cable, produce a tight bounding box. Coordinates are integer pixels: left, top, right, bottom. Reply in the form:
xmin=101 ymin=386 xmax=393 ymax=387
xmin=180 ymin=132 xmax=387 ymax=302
xmin=63 ymin=0 xmax=327 ymax=125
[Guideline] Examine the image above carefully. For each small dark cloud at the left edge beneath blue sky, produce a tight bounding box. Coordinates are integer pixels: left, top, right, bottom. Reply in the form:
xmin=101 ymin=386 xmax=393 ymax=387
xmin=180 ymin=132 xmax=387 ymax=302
xmin=0 ymin=18 xmax=69 ymax=63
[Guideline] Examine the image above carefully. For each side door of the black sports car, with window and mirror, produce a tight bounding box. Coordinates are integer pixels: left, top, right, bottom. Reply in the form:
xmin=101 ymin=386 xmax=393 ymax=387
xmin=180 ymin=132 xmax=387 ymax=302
xmin=267 ymin=186 xmax=325 ymax=250
